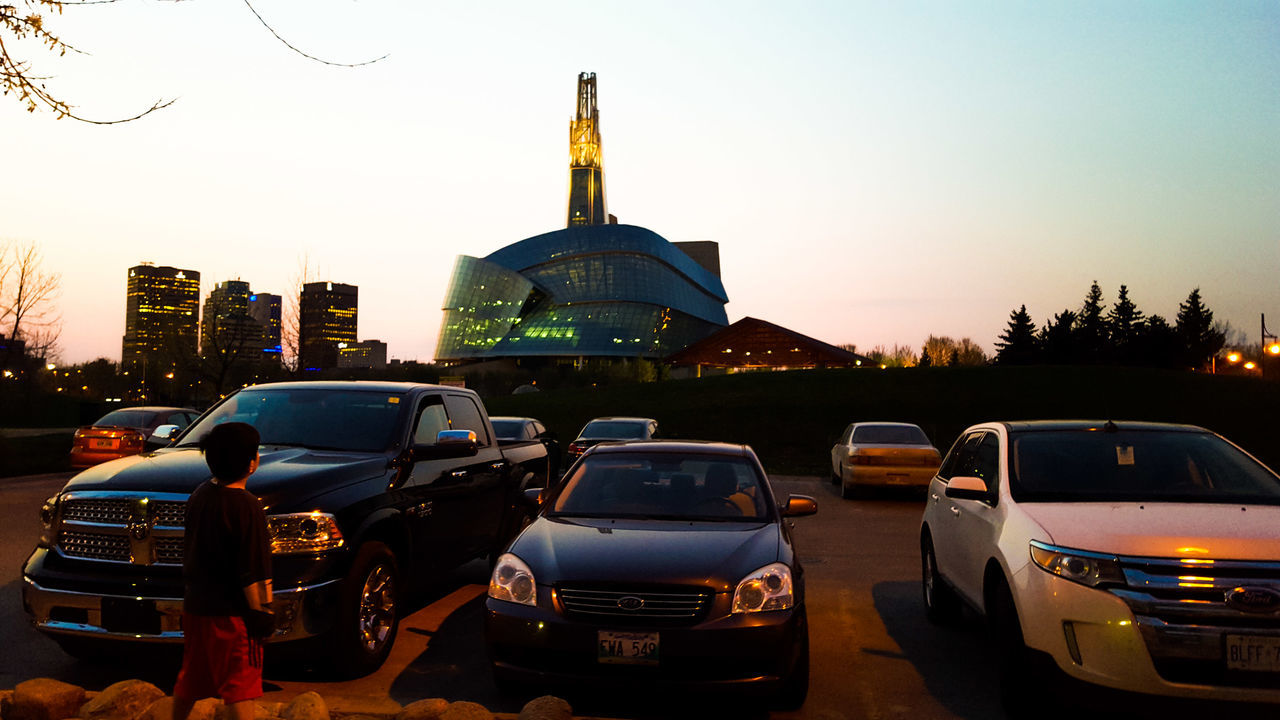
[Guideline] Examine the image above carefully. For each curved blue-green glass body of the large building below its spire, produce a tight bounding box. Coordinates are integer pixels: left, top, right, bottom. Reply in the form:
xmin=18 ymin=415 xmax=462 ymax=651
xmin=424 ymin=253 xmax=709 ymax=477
xmin=435 ymin=224 xmax=728 ymax=364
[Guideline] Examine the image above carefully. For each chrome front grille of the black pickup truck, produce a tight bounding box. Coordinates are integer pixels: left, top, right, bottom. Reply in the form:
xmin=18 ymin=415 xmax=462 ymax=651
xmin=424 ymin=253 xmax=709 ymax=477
xmin=56 ymin=492 xmax=187 ymax=565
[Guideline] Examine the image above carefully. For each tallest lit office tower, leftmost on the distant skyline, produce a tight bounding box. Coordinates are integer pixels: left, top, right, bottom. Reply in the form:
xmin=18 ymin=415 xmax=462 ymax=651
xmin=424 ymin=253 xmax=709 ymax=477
xmin=120 ymin=263 xmax=200 ymax=375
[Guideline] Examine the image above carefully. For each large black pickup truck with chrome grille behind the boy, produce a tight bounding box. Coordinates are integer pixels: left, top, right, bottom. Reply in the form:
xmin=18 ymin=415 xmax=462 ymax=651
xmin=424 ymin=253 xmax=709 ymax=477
xmin=22 ymin=382 xmax=549 ymax=674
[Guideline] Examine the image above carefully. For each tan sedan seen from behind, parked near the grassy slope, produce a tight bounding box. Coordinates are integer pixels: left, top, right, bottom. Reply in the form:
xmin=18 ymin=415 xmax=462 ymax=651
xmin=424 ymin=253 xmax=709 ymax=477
xmin=831 ymin=423 xmax=942 ymax=498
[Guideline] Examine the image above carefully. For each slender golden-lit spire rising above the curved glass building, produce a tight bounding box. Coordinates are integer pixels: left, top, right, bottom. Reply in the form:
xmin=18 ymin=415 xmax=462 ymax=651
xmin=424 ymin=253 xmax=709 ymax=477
xmin=568 ymin=73 xmax=609 ymax=228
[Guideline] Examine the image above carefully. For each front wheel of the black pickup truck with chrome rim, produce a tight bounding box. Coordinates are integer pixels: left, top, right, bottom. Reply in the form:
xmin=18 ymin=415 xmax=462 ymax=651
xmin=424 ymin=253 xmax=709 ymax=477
xmin=330 ymin=542 xmax=399 ymax=676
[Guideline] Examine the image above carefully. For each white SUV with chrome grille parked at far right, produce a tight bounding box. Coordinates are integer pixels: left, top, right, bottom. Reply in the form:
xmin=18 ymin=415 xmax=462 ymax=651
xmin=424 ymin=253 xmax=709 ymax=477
xmin=920 ymin=421 xmax=1280 ymax=714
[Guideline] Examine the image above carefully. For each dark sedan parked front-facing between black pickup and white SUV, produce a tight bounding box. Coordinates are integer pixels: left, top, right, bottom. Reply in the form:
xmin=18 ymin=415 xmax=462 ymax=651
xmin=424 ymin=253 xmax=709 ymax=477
xmin=485 ymin=441 xmax=817 ymax=707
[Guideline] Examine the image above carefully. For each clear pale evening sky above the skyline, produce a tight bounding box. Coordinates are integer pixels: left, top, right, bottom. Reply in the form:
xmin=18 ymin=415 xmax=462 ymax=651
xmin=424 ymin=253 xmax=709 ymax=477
xmin=0 ymin=0 xmax=1280 ymax=363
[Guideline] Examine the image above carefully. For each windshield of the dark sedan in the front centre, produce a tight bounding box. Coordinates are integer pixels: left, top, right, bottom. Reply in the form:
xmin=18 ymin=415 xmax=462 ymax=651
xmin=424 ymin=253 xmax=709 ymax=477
xmin=548 ymin=452 xmax=768 ymax=520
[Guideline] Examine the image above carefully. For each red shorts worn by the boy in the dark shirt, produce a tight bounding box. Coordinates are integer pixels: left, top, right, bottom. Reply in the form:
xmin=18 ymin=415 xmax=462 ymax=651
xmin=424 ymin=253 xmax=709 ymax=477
xmin=173 ymin=612 xmax=262 ymax=705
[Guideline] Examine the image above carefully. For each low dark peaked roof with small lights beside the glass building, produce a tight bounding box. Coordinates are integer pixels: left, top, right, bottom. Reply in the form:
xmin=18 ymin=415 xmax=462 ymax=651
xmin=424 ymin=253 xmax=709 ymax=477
xmin=667 ymin=318 xmax=872 ymax=370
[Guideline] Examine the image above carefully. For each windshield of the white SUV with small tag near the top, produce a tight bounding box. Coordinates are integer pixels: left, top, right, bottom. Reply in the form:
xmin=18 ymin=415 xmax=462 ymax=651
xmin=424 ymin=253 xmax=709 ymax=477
xmin=1009 ymin=429 xmax=1280 ymax=505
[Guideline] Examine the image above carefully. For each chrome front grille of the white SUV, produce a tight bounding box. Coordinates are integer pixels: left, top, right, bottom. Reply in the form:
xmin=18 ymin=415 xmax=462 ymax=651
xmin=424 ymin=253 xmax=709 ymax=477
xmin=1110 ymin=557 xmax=1280 ymax=687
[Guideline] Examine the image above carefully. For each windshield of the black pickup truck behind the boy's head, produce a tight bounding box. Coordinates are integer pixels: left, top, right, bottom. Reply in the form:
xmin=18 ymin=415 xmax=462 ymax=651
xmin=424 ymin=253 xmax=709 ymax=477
xmin=179 ymin=388 xmax=406 ymax=452
